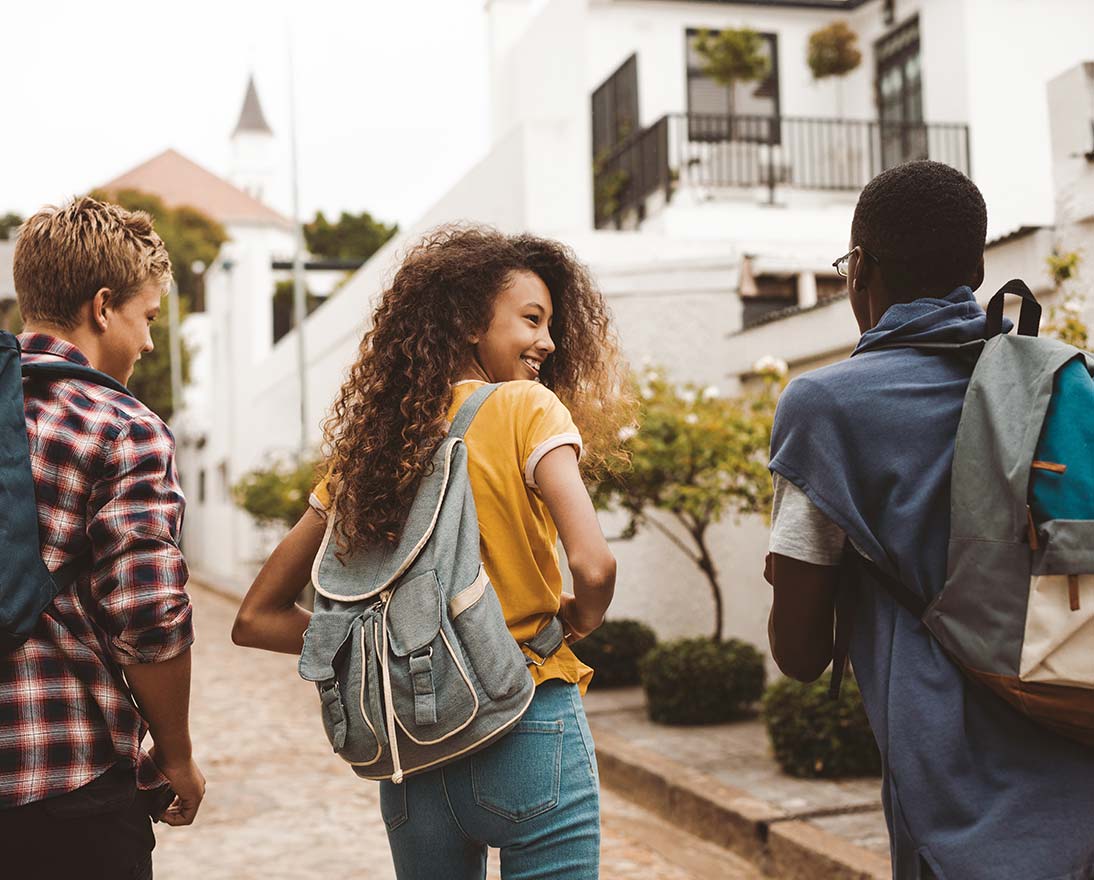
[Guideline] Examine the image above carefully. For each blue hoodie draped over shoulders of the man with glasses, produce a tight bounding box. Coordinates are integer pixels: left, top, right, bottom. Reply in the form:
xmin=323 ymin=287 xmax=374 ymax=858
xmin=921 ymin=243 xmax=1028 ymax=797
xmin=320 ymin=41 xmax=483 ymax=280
xmin=770 ymin=287 xmax=1094 ymax=880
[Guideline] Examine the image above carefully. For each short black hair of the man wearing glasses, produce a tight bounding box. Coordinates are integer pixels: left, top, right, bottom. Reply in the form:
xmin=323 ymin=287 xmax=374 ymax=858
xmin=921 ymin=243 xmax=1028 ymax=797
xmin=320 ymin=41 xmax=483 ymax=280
xmin=851 ymin=160 xmax=988 ymax=299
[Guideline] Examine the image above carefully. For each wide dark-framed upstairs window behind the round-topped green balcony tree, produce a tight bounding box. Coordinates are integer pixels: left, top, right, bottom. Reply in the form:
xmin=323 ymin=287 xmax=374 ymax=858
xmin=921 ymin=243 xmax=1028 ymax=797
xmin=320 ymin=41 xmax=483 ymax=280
xmin=686 ymin=27 xmax=779 ymax=143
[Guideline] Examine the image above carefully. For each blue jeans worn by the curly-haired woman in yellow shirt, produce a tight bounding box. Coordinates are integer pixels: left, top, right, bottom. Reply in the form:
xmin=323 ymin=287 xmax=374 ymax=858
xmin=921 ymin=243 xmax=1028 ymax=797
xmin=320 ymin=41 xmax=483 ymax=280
xmin=380 ymin=681 xmax=601 ymax=880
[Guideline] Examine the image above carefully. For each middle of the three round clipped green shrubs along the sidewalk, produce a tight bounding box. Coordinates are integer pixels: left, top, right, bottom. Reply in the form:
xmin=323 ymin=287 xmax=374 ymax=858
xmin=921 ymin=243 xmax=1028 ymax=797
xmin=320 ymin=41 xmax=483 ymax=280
xmin=639 ymin=638 xmax=764 ymax=725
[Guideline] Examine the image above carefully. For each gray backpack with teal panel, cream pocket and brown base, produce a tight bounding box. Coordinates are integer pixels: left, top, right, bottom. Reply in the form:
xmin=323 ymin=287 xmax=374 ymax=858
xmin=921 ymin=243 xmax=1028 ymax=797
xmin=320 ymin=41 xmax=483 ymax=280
xmin=833 ymin=280 xmax=1094 ymax=745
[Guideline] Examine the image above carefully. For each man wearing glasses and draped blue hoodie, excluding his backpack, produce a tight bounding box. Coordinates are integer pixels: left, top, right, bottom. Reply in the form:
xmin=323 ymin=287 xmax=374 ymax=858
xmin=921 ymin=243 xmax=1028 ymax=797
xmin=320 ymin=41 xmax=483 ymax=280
xmin=765 ymin=161 xmax=1094 ymax=880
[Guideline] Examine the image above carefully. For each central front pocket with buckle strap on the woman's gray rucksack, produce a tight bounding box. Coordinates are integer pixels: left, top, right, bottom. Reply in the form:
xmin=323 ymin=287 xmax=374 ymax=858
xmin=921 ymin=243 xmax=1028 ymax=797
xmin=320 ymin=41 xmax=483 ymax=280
xmin=386 ymin=571 xmax=479 ymax=745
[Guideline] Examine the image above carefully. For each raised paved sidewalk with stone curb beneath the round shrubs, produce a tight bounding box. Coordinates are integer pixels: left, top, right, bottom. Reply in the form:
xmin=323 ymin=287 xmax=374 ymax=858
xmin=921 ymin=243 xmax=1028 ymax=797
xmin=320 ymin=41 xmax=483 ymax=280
xmin=585 ymin=687 xmax=889 ymax=880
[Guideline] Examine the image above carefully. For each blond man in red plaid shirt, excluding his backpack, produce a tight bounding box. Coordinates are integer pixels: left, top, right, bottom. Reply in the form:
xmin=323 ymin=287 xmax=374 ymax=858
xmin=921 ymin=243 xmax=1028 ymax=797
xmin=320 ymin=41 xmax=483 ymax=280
xmin=0 ymin=198 xmax=205 ymax=878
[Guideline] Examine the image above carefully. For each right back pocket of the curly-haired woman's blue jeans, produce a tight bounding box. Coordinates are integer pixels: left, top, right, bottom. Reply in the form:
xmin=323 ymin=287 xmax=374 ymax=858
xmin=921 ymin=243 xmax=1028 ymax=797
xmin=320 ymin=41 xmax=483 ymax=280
xmin=470 ymin=721 xmax=562 ymax=822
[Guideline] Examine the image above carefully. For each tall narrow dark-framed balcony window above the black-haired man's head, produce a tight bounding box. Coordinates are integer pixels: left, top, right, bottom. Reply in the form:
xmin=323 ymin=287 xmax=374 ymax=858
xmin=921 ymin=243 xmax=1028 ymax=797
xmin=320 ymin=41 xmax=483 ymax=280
xmin=874 ymin=18 xmax=928 ymax=169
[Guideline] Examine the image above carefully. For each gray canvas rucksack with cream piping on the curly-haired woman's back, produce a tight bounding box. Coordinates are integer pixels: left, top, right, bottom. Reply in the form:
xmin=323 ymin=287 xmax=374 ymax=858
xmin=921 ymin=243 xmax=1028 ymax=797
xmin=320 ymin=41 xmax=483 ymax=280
xmin=300 ymin=385 xmax=562 ymax=783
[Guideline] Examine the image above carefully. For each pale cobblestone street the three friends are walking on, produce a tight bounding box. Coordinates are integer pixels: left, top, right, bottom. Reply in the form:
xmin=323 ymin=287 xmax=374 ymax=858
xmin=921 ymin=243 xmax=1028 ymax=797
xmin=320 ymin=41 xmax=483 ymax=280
xmin=155 ymin=586 xmax=760 ymax=880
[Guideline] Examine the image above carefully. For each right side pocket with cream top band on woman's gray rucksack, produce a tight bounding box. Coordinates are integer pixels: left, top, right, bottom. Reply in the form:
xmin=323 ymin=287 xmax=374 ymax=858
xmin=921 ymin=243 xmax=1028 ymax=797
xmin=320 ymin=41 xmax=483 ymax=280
xmin=449 ymin=567 xmax=528 ymax=699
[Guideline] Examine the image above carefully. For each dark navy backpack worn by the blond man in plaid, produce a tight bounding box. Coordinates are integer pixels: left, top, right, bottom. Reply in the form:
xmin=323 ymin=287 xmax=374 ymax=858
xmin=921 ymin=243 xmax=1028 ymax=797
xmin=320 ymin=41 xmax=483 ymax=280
xmin=0 ymin=331 xmax=129 ymax=652
